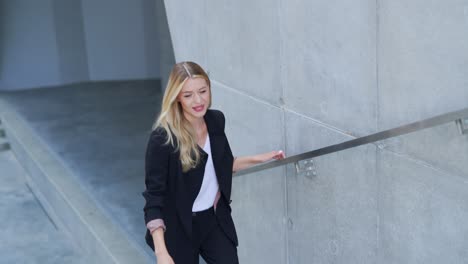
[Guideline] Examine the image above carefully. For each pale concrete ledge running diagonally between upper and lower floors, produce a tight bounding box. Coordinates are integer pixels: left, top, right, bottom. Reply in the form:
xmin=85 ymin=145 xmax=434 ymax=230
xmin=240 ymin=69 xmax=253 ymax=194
xmin=2 ymin=112 xmax=152 ymax=264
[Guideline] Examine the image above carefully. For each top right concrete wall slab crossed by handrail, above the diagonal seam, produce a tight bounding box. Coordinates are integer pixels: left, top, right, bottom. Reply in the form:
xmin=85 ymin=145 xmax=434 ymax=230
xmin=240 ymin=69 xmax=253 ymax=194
xmin=378 ymin=0 xmax=468 ymax=190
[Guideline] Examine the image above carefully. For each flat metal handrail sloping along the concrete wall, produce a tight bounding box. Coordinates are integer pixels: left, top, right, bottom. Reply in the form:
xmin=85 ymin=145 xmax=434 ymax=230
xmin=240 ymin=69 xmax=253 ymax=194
xmin=233 ymin=108 xmax=468 ymax=177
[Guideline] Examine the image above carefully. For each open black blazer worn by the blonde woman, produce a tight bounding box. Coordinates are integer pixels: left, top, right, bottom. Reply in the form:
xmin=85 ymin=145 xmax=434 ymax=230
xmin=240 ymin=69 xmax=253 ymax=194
xmin=142 ymin=109 xmax=238 ymax=256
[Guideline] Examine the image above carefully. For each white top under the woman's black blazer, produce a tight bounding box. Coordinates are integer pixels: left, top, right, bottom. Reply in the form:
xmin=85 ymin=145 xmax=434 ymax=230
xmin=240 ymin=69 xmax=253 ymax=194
xmin=192 ymin=134 xmax=219 ymax=212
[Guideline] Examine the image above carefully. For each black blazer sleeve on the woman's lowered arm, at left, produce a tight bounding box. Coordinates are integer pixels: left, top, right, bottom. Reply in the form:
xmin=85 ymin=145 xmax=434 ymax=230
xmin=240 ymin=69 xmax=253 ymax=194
xmin=142 ymin=128 xmax=171 ymax=224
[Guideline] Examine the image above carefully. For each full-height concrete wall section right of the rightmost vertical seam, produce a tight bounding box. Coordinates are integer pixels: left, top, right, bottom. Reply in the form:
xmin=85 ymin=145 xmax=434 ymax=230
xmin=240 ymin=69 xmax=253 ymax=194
xmin=377 ymin=0 xmax=468 ymax=263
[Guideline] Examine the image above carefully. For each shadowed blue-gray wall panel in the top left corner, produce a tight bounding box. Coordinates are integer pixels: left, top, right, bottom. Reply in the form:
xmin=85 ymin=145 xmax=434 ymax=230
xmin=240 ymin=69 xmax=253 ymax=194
xmin=0 ymin=0 xmax=60 ymax=90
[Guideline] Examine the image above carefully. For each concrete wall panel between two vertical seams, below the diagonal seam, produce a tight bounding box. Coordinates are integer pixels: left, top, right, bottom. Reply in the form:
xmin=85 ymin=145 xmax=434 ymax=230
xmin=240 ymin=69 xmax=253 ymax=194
xmin=286 ymin=113 xmax=379 ymax=264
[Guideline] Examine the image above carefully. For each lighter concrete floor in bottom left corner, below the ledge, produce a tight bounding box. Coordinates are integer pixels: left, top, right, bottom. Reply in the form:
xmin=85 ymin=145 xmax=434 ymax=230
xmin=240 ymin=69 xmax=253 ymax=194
xmin=0 ymin=151 xmax=85 ymax=264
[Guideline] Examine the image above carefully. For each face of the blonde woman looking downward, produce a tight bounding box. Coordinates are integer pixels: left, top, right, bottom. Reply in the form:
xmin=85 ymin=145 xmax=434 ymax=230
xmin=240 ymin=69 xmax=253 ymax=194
xmin=177 ymin=78 xmax=211 ymax=120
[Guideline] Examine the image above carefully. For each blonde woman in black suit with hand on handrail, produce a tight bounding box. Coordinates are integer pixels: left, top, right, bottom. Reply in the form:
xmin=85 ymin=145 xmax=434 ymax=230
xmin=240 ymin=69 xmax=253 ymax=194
xmin=143 ymin=62 xmax=284 ymax=264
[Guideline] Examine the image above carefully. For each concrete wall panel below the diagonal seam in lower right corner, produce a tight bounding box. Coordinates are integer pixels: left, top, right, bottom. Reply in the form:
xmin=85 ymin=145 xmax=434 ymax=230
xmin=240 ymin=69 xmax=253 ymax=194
xmin=378 ymin=151 xmax=468 ymax=263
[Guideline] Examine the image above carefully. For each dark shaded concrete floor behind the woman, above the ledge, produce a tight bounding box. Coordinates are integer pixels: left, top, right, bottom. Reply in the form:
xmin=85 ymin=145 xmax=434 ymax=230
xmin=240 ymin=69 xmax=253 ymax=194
xmin=0 ymin=81 xmax=161 ymax=263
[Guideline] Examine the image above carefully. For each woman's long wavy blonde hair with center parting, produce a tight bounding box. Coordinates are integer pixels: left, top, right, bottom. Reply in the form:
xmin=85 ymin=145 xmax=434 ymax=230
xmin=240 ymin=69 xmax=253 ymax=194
xmin=153 ymin=61 xmax=211 ymax=172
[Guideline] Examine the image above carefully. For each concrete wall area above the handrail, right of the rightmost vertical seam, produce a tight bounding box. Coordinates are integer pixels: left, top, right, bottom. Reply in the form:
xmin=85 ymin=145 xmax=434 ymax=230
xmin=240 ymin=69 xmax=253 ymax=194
xmin=379 ymin=0 xmax=468 ymax=130
